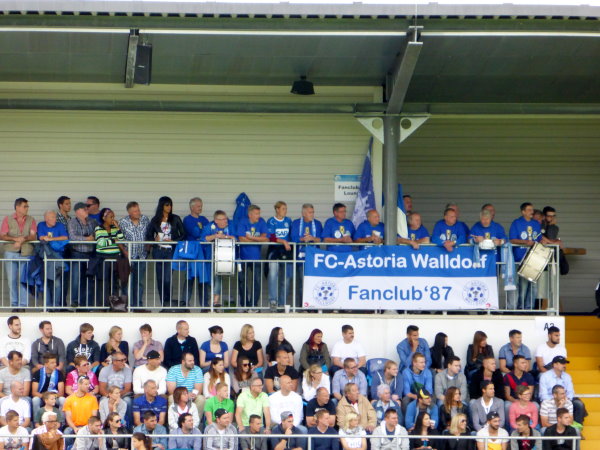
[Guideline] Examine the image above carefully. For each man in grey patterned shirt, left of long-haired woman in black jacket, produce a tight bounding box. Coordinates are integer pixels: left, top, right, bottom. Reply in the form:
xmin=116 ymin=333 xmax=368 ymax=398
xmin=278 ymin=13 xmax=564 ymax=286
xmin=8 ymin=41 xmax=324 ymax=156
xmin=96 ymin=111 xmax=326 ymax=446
xmin=119 ymin=202 xmax=150 ymax=312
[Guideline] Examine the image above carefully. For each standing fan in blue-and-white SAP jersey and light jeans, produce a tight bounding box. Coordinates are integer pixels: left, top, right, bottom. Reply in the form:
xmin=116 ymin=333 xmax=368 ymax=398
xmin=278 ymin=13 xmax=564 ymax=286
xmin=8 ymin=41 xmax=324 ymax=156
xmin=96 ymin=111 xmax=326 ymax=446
xmin=267 ymin=201 xmax=293 ymax=312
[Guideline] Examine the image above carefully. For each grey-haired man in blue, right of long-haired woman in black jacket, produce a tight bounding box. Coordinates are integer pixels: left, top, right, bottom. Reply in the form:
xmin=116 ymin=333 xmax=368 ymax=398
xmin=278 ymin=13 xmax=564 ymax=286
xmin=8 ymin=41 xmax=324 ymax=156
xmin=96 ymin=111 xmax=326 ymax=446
xmin=181 ymin=197 xmax=210 ymax=308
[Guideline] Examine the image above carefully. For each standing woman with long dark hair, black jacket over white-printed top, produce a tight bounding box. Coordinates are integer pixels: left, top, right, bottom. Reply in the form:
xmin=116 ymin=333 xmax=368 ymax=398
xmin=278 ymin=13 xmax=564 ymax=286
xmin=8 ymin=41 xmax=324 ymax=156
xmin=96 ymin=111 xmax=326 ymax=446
xmin=146 ymin=197 xmax=185 ymax=308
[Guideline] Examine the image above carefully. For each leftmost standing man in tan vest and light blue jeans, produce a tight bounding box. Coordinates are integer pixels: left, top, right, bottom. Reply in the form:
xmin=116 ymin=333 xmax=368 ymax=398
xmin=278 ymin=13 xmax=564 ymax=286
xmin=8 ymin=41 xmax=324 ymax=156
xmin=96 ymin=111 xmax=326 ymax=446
xmin=0 ymin=197 xmax=37 ymax=312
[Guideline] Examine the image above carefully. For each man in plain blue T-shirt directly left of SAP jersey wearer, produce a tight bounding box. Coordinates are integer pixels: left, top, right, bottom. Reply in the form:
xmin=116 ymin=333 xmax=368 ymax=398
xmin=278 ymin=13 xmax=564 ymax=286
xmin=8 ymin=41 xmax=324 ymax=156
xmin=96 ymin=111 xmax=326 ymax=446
xmin=237 ymin=205 xmax=269 ymax=312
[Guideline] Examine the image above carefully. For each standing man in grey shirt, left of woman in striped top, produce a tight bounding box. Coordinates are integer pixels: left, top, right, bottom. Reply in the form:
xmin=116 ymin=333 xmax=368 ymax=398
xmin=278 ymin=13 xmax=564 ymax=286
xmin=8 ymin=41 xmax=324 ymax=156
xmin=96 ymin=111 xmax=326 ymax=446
xmin=67 ymin=202 xmax=98 ymax=310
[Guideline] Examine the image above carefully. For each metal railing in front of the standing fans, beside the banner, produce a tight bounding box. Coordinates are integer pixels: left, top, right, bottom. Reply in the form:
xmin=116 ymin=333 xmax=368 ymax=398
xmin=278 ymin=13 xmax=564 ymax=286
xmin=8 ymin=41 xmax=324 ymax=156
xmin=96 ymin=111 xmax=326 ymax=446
xmin=0 ymin=241 xmax=559 ymax=314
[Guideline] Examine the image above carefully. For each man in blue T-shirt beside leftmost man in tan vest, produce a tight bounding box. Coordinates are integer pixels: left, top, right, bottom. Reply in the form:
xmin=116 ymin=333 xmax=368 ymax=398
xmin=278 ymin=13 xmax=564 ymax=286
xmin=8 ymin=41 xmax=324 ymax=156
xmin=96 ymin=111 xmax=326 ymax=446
xmin=37 ymin=211 xmax=69 ymax=308
